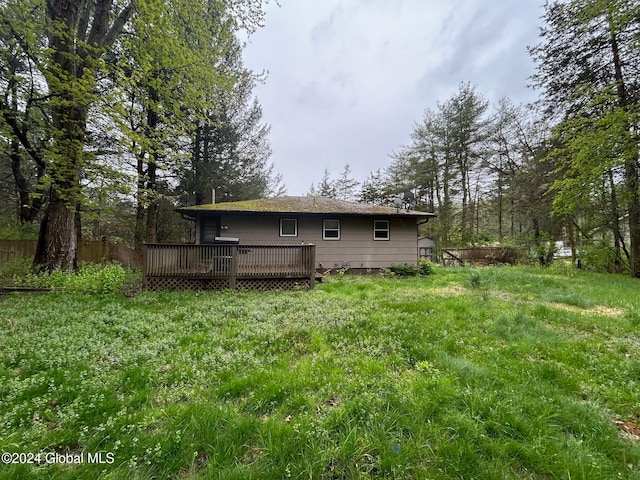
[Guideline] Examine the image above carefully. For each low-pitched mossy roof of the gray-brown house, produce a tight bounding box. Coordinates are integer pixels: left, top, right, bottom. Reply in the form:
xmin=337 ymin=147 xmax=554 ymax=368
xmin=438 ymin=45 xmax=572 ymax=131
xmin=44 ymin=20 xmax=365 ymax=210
xmin=176 ymin=197 xmax=436 ymax=219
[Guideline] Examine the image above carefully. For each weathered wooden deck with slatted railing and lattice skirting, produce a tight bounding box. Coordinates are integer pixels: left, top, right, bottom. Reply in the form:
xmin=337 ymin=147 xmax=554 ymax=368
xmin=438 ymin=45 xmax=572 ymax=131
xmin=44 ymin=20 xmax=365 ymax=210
xmin=143 ymin=244 xmax=316 ymax=290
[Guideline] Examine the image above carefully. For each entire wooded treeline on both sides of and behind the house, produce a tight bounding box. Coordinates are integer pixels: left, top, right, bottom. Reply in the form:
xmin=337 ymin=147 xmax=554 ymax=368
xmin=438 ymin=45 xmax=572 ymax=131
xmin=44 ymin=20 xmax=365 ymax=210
xmin=0 ymin=0 xmax=640 ymax=276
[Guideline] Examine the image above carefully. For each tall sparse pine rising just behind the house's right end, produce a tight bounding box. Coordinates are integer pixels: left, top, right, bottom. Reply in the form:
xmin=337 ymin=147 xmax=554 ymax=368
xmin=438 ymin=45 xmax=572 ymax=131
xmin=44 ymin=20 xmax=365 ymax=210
xmin=387 ymin=83 xmax=490 ymax=244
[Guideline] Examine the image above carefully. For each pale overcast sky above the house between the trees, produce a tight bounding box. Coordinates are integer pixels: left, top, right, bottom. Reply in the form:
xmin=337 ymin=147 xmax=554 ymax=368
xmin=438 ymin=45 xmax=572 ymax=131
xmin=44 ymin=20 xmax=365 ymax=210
xmin=244 ymin=0 xmax=544 ymax=195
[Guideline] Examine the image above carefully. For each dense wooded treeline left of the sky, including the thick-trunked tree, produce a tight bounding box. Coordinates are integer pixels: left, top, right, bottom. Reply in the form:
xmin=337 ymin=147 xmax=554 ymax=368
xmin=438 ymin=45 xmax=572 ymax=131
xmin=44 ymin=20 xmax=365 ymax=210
xmin=0 ymin=0 xmax=282 ymax=270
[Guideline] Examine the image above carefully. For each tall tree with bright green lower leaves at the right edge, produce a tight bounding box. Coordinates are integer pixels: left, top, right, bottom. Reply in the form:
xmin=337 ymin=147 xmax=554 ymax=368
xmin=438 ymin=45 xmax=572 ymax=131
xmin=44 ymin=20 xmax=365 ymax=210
xmin=530 ymin=0 xmax=640 ymax=277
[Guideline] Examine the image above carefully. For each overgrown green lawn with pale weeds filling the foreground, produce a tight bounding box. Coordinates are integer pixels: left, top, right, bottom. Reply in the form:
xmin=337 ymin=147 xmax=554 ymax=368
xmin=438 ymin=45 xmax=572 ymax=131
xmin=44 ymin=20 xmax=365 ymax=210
xmin=0 ymin=267 xmax=640 ymax=480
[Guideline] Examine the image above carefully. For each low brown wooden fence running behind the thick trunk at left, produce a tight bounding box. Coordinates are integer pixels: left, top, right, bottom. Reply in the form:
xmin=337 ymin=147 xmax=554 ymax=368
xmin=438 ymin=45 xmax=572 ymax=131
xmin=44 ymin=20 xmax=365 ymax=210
xmin=0 ymin=240 xmax=142 ymax=267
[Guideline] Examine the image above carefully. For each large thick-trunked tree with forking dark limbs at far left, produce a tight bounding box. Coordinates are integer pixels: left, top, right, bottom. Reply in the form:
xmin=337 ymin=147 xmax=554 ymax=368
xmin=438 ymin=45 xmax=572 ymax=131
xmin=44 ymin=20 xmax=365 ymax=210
xmin=1 ymin=0 xmax=133 ymax=270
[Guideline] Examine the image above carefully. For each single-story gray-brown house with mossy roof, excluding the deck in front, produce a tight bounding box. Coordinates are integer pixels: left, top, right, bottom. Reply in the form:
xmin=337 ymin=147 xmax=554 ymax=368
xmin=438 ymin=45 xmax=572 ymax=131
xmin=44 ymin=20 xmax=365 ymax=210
xmin=177 ymin=197 xmax=435 ymax=272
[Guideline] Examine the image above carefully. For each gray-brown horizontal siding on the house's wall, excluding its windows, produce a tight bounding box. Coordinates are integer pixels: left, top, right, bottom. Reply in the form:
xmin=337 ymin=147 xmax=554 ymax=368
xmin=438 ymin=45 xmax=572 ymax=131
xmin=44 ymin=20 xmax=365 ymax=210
xmin=196 ymin=214 xmax=418 ymax=269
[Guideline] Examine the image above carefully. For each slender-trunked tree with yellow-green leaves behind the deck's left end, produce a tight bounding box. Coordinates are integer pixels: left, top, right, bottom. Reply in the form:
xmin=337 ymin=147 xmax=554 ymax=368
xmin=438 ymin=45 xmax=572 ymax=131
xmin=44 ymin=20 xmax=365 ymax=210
xmin=111 ymin=0 xmax=241 ymax=246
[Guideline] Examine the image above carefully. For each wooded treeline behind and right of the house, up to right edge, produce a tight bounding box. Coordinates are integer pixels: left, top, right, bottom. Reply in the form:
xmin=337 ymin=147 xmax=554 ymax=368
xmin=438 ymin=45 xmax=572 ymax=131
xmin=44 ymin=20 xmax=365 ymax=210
xmin=310 ymin=0 xmax=640 ymax=277
